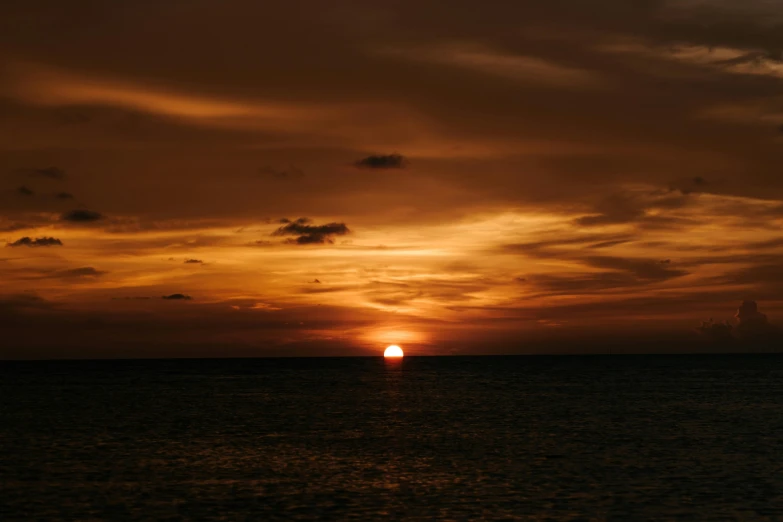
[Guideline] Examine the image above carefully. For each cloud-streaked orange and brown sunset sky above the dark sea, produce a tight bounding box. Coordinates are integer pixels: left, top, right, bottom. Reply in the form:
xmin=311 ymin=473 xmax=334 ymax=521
xmin=0 ymin=0 xmax=783 ymax=358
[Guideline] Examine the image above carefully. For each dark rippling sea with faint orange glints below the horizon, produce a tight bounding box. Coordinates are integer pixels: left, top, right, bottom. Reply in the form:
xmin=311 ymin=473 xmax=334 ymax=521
xmin=0 ymin=355 xmax=783 ymax=521
